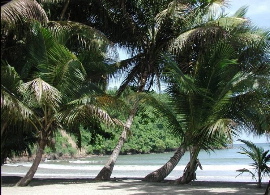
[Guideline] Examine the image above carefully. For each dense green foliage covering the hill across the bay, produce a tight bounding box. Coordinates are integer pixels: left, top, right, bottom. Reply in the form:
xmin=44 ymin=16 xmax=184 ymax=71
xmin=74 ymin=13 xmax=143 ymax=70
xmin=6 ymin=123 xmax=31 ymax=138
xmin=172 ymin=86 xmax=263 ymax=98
xmin=38 ymin=92 xmax=232 ymax=154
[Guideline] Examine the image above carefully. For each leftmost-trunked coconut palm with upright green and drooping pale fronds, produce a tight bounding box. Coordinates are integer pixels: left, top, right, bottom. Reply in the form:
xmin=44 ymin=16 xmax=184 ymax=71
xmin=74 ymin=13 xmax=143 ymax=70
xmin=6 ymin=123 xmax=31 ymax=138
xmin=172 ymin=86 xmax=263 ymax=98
xmin=1 ymin=24 xmax=117 ymax=186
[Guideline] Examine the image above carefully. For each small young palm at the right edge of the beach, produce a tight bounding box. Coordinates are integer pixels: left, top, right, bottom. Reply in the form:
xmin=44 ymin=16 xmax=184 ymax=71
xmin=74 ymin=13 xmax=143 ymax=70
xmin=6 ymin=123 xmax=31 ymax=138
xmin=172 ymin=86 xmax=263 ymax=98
xmin=237 ymin=139 xmax=270 ymax=187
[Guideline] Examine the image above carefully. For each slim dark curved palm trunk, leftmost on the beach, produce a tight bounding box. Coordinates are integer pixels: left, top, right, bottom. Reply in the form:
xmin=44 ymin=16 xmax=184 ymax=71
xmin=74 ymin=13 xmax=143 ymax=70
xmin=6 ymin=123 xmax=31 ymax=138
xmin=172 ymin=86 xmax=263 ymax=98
xmin=16 ymin=139 xmax=46 ymax=186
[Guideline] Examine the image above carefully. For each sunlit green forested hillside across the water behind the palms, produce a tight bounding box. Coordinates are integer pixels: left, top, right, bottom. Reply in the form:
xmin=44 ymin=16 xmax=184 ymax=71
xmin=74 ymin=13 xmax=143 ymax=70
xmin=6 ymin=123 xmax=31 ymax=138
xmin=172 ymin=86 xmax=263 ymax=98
xmin=40 ymin=93 xmax=181 ymax=157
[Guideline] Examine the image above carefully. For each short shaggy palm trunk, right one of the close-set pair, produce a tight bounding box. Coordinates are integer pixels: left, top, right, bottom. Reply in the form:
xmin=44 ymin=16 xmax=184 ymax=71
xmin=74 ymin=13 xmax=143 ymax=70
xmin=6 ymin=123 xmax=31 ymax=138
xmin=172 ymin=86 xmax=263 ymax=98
xmin=176 ymin=148 xmax=202 ymax=184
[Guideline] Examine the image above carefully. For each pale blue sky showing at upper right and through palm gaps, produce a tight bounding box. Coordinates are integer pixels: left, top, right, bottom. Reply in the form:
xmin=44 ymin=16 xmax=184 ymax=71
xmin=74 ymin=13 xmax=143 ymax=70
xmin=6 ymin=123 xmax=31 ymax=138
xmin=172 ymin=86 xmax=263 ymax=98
xmin=109 ymin=0 xmax=270 ymax=143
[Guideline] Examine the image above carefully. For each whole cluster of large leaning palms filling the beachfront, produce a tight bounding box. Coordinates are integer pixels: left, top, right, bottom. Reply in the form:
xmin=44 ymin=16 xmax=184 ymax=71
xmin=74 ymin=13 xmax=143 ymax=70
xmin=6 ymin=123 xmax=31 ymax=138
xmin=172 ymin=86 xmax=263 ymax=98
xmin=1 ymin=0 xmax=270 ymax=186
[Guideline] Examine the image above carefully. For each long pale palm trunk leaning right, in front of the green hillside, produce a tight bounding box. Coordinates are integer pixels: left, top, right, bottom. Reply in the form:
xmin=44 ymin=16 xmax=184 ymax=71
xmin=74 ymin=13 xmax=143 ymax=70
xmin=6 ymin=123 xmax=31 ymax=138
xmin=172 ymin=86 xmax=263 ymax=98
xmin=95 ymin=103 xmax=138 ymax=181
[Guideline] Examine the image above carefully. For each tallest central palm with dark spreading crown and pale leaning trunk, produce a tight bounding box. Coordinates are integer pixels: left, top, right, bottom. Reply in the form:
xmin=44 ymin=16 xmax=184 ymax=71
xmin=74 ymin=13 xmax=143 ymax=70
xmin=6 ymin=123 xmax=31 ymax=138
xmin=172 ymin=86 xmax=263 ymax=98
xmin=89 ymin=1 xmax=228 ymax=180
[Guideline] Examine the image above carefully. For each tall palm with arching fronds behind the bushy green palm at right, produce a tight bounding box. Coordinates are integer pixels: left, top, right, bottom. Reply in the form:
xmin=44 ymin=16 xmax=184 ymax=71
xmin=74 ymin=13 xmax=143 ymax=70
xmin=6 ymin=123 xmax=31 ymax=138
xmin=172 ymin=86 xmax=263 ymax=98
xmin=145 ymin=3 xmax=269 ymax=181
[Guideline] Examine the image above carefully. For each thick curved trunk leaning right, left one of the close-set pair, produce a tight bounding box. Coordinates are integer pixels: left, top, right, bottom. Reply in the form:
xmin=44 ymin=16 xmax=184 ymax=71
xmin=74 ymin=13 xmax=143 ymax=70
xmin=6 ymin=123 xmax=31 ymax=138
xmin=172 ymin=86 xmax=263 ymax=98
xmin=143 ymin=145 xmax=186 ymax=182
